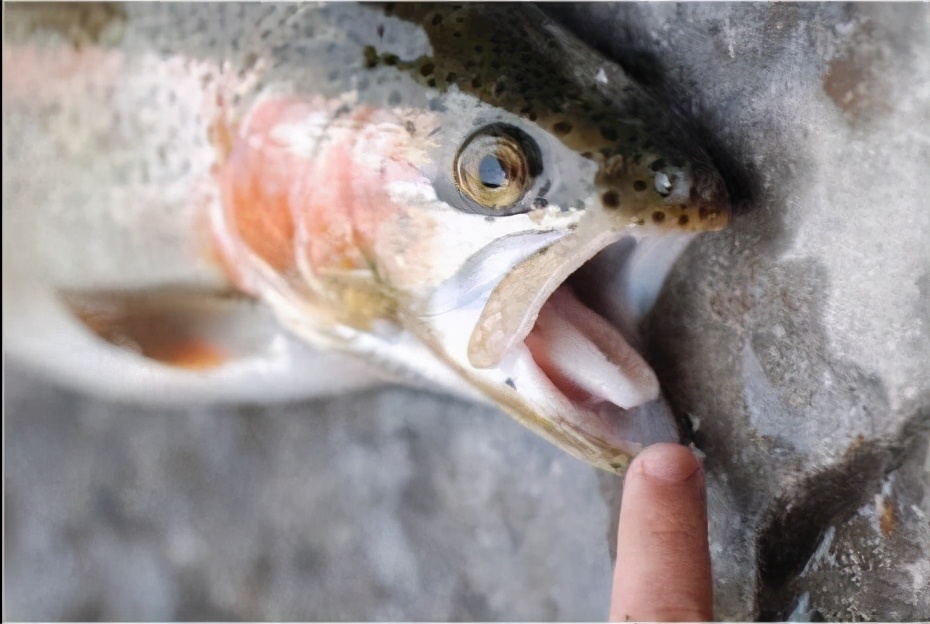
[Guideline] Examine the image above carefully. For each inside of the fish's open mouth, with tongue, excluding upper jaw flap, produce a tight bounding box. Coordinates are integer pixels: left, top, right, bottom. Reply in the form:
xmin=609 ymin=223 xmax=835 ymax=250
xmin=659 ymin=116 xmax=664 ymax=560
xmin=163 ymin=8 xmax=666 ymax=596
xmin=482 ymin=234 xmax=693 ymax=464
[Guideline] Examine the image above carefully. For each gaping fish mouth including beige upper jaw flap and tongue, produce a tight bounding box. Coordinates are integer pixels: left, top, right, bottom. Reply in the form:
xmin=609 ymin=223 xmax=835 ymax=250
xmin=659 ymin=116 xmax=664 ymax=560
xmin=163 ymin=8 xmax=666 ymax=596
xmin=426 ymin=173 xmax=729 ymax=471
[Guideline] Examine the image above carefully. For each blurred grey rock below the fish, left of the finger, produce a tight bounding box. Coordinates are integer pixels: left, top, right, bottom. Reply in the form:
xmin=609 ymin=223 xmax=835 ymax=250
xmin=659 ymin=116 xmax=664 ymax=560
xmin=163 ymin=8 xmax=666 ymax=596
xmin=3 ymin=366 xmax=611 ymax=621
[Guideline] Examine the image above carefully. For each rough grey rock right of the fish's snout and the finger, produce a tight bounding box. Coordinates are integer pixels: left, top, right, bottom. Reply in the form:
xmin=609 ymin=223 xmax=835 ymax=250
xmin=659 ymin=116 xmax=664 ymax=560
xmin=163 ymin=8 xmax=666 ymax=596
xmin=551 ymin=4 xmax=930 ymax=621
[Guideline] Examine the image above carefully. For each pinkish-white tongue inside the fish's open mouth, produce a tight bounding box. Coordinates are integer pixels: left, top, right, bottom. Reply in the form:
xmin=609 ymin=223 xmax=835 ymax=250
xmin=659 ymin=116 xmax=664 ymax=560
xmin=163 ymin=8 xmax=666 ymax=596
xmin=526 ymin=284 xmax=659 ymax=409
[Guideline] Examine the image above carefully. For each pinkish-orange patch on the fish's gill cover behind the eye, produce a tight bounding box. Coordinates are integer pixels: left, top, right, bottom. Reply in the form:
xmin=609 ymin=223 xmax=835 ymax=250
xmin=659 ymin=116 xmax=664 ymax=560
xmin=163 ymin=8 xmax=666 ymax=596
xmin=217 ymin=97 xmax=419 ymax=290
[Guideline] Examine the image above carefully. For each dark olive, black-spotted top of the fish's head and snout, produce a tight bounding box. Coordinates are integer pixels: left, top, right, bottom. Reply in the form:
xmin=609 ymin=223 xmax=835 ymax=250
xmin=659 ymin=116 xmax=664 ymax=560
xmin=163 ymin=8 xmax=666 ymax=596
xmin=365 ymin=3 xmax=727 ymax=231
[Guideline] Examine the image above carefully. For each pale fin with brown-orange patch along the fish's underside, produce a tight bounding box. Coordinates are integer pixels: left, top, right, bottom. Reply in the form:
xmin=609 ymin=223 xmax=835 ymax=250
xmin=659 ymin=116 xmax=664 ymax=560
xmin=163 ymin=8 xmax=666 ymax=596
xmin=4 ymin=288 xmax=383 ymax=405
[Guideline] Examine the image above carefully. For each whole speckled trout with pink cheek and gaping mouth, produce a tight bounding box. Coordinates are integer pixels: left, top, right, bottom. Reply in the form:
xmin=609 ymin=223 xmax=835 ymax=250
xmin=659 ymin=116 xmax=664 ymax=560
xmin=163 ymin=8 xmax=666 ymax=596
xmin=3 ymin=2 xmax=731 ymax=473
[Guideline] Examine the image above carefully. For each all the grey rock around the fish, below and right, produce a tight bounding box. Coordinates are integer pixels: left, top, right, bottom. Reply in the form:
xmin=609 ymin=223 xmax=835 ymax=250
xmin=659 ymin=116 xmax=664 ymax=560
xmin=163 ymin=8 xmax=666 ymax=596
xmin=4 ymin=3 xmax=930 ymax=621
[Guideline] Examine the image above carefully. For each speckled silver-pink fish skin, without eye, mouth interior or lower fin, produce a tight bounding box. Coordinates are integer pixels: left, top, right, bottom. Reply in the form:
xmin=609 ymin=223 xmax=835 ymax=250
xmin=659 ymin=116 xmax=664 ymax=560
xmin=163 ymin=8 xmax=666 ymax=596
xmin=4 ymin=4 xmax=728 ymax=469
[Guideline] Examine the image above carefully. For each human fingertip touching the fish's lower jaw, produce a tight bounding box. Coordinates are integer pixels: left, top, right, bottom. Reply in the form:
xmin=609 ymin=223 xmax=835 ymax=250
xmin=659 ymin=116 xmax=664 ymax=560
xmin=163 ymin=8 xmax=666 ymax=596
xmin=610 ymin=444 xmax=713 ymax=622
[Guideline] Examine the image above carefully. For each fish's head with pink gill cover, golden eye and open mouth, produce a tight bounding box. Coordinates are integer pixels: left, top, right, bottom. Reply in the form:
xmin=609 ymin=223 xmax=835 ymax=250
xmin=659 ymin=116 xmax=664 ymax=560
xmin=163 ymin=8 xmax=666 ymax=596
xmin=208 ymin=5 xmax=729 ymax=471
